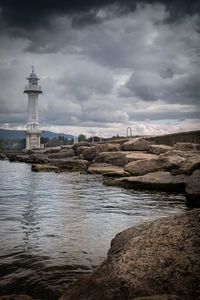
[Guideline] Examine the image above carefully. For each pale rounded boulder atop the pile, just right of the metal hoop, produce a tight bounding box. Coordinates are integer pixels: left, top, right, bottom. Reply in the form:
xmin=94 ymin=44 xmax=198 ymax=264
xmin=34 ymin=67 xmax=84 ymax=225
xmin=121 ymin=138 xmax=152 ymax=151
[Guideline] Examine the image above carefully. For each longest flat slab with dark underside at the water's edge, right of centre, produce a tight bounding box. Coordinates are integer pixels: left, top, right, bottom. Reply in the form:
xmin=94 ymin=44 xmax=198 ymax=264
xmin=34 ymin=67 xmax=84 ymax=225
xmin=105 ymin=171 xmax=187 ymax=192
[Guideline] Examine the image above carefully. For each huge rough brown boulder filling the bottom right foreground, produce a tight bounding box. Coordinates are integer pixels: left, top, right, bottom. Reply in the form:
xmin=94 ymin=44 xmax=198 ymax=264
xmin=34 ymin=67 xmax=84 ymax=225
xmin=60 ymin=209 xmax=200 ymax=300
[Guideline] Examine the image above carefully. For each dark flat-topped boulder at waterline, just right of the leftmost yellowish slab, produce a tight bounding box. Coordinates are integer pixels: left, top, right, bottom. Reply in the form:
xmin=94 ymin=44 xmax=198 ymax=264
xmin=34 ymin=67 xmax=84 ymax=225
xmin=49 ymin=158 xmax=88 ymax=171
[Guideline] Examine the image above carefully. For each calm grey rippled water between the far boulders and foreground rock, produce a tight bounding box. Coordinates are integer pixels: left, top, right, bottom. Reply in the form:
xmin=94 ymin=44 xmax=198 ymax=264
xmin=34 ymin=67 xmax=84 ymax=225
xmin=0 ymin=161 xmax=187 ymax=300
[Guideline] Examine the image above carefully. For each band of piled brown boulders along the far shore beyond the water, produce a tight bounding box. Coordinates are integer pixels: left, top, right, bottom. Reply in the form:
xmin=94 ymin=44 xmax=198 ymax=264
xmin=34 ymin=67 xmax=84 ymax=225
xmin=0 ymin=132 xmax=200 ymax=207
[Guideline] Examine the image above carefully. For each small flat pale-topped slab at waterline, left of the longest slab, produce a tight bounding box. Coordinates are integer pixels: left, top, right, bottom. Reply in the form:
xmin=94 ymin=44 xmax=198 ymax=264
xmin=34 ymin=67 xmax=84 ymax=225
xmin=88 ymin=163 xmax=129 ymax=177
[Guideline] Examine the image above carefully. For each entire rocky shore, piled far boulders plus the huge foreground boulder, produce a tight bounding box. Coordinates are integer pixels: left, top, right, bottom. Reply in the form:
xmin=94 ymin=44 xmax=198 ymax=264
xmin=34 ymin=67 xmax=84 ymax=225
xmin=0 ymin=131 xmax=200 ymax=300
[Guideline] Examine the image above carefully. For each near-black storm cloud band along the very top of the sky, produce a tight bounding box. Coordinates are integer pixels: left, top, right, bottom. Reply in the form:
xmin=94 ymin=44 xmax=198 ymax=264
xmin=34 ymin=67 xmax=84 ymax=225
xmin=0 ymin=0 xmax=200 ymax=33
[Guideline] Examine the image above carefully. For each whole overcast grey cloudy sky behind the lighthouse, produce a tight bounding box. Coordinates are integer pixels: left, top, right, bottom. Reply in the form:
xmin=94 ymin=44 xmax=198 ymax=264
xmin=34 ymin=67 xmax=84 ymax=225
xmin=0 ymin=0 xmax=200 ymax=137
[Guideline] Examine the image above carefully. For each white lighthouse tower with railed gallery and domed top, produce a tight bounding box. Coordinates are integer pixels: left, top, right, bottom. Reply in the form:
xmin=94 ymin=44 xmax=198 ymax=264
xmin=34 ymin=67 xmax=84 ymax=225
xmin=24 ymin=67 xmax=42 ymax=149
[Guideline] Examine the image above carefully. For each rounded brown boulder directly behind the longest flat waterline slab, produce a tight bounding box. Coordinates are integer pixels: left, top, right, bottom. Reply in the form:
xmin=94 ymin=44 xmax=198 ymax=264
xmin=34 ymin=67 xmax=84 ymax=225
xmin=124 ymin=159 xmax=163 ymax=176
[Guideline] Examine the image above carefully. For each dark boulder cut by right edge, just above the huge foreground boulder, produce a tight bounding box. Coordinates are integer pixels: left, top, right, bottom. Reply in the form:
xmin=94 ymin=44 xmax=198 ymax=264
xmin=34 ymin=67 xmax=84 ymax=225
xmin=185 ymin=170 xmax=200 ymax=207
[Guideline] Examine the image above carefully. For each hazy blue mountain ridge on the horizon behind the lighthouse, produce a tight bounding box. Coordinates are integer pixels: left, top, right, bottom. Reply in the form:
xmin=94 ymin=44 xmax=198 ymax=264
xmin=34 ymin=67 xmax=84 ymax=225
xmin=0 ymin=129 xmax=74 ymax=140
